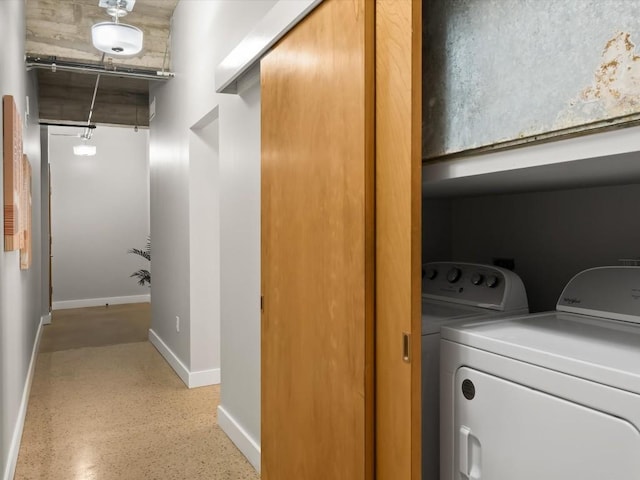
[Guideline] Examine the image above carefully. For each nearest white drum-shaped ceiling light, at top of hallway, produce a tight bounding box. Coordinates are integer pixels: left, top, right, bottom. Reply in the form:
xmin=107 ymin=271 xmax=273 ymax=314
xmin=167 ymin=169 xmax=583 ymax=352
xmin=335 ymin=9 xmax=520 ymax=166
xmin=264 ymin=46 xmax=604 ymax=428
xmin=91 ymin=0 xmax=143 ymax=56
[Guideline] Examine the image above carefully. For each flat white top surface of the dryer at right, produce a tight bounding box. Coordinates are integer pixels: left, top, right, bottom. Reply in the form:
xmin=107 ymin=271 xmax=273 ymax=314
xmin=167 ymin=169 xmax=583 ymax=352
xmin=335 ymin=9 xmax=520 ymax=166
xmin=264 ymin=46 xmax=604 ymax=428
xmin=441 ymin=312 xmax=640 ymax=394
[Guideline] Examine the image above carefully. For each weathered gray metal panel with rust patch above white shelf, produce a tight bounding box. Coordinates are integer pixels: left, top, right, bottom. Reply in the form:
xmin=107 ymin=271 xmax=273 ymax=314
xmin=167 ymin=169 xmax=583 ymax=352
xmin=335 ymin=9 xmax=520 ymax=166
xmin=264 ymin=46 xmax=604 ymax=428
xmin=423 ymin=0 xmax=640 ymax=158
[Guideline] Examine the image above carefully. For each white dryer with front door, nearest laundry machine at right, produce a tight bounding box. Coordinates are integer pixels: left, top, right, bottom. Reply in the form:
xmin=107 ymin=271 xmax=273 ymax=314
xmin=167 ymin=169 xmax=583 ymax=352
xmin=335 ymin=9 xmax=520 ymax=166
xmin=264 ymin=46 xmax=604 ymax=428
xmin=440 ymin=267 xmax=640 ymax=480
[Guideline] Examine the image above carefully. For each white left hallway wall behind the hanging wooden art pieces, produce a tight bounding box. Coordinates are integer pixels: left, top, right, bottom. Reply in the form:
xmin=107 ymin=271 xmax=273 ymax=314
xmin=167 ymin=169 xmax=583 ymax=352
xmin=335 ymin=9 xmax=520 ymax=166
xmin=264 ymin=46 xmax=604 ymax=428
xmin=0 ymin=0 xmax=48 ymax=480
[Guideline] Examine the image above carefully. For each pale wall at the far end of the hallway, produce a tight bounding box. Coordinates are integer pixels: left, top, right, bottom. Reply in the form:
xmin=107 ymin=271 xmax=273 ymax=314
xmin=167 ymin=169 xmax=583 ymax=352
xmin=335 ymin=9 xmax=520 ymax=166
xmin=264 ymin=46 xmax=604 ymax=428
xmin=49 ymin=126 xmax=149 ymax=309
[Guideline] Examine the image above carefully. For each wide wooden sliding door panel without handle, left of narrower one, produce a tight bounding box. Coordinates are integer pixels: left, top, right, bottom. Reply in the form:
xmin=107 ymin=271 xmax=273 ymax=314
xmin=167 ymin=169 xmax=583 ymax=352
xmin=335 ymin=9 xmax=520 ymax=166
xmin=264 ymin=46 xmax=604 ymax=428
xmin=261 ymin=0 xmax=376 ymax=480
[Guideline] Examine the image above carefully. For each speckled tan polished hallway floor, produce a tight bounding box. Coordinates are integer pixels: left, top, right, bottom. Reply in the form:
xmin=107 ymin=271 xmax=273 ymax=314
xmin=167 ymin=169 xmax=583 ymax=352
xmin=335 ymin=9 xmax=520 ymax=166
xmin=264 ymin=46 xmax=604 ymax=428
xmin=15 ymin=304 xmax=259 ymax=480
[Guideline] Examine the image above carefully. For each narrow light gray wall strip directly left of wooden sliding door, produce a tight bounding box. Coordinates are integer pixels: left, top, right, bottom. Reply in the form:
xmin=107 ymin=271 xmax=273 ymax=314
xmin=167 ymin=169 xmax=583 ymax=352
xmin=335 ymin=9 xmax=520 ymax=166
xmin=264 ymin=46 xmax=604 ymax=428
xmin=220 ymin=66 xmax=261 ymax=454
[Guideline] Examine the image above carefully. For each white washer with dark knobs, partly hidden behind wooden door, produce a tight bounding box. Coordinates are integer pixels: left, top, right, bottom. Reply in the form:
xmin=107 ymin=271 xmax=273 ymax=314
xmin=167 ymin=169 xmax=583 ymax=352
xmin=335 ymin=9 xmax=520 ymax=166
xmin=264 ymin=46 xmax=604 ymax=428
xmin=422 ymin=262 xmax=529 ymax=480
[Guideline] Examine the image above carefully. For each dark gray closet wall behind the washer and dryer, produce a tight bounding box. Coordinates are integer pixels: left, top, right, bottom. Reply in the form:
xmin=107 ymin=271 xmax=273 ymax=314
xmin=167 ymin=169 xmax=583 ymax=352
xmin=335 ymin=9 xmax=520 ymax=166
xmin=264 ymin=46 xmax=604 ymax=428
xmin=423 ymin=185 xmax=640 ymax=311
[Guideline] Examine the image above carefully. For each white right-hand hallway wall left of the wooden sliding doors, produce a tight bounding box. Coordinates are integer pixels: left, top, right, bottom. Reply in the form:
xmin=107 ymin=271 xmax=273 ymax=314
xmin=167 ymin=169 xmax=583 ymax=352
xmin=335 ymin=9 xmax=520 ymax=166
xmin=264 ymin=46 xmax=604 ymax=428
xmin=150 ymin=0 xmax=275 ymax=467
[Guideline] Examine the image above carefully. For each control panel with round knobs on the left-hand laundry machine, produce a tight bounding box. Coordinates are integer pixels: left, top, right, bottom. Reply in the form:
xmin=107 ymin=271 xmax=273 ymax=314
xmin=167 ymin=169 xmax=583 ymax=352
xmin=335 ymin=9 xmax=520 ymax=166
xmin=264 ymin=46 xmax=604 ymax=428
xmin=422 ymin=262 xmax=528 ymax=311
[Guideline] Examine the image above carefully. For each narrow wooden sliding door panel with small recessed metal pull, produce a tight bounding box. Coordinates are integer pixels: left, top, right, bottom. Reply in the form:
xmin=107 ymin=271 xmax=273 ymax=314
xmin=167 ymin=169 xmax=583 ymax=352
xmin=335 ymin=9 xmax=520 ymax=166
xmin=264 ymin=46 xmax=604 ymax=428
xmin=376 ymin=0 xmax=422 ymax=480
